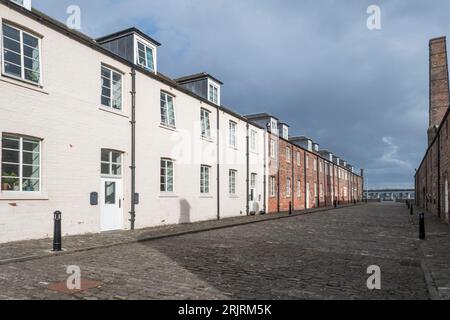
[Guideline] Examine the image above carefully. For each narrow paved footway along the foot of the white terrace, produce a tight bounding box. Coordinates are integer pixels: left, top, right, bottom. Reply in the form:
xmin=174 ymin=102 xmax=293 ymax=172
xmin=0 ymin=203 xmax=363 ymax=265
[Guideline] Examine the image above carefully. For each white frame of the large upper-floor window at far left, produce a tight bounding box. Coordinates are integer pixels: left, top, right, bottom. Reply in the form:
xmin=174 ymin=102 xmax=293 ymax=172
xmin=0 ymin=20 xmax=43 ymax=86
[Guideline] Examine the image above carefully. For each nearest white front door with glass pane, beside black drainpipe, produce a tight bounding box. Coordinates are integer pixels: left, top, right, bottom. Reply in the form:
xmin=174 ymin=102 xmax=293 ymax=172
xmin=100 ymin=178 xmax=123 ymax=231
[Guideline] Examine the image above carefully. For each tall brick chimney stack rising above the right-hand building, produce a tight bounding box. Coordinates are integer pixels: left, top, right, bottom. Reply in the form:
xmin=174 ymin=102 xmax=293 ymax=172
xmin=428 ymin=37 xmax=450 ymax=145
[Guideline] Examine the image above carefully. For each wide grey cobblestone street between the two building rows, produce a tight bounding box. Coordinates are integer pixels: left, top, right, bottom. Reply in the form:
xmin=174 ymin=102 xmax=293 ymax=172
xmin=0 ymin=203 xmax=444 ymax=299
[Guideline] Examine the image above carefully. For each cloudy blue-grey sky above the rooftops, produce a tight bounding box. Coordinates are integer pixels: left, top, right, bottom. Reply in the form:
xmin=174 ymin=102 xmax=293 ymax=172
xmin=33 ymin=0 xmax=450 ymax=188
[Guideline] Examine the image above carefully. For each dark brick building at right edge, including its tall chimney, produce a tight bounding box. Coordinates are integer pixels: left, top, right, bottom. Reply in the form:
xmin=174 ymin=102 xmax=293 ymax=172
xmin=415 ymin=37 xmax=450 ymax=222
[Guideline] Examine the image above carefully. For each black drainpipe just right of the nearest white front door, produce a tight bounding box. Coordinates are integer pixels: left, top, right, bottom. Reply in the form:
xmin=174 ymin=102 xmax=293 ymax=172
xmin=130 ymin=68 xmax=136 ymax=230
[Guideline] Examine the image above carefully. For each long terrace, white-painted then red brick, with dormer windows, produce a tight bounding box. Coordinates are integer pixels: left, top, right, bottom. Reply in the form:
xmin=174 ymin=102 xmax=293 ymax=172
xmin=0 ymin=0 xmax=363 ymax=242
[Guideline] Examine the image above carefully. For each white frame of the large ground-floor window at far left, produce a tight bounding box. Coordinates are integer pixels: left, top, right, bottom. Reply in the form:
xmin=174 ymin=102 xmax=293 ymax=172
xmin=0 ymin=134 xmax=42 ymax=194
